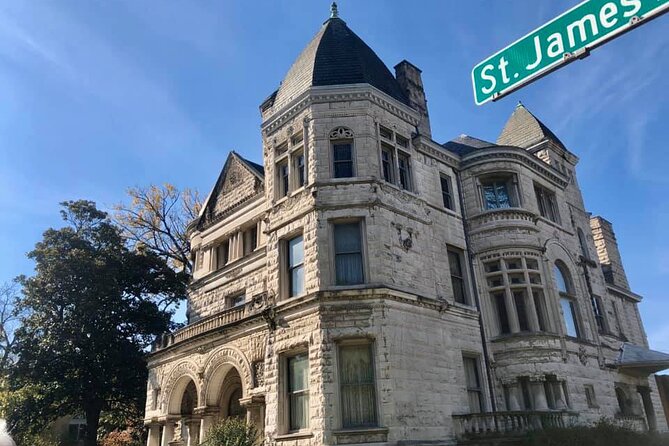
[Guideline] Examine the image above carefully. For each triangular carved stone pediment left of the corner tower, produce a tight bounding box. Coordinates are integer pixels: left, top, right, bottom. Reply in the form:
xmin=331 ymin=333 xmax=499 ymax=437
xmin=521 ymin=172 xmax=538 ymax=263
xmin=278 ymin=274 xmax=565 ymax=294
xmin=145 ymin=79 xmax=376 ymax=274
xmin=198 ymin=152 xmax=265 ymax=229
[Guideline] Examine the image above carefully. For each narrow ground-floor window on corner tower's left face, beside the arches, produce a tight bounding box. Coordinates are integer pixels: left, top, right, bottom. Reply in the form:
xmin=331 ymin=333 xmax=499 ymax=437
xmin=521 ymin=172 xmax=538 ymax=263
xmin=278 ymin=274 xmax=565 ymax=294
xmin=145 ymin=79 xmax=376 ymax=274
xmin=286 ymin=353 xmax=309 ymax=431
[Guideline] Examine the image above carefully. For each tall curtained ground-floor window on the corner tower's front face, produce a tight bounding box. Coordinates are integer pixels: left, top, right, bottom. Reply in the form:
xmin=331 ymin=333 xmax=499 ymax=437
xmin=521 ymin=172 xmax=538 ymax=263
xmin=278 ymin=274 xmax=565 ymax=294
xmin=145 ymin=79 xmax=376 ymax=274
xmin=339 ymin=344 xmax=377 ymax=428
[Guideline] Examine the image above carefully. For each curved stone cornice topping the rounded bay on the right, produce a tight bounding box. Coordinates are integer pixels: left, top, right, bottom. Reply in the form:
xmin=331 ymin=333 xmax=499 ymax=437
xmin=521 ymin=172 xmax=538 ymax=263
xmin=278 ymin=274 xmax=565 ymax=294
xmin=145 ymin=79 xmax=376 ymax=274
xmin=461 ymin=146 xmax=569 ymax=189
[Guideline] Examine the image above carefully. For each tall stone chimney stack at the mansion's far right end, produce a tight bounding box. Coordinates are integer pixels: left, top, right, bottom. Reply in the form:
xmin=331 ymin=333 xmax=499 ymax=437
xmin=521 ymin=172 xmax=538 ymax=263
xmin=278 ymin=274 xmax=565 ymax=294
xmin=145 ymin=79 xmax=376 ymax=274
xmin=590 ymin=216 xmax=630 ymax=290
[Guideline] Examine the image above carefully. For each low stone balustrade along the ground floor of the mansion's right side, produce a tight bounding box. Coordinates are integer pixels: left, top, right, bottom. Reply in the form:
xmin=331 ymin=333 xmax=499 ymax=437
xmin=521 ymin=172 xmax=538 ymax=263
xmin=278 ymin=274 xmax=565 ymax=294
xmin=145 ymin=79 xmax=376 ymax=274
xmin=453 ymin=411 xmax=578 ymax=440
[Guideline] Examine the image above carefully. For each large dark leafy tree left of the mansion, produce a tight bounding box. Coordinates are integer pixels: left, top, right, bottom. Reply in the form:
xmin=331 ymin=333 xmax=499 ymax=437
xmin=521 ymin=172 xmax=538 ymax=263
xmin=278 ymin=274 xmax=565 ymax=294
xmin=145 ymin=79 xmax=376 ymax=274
xmin=10 ymin=200 xmax=185 ymax=446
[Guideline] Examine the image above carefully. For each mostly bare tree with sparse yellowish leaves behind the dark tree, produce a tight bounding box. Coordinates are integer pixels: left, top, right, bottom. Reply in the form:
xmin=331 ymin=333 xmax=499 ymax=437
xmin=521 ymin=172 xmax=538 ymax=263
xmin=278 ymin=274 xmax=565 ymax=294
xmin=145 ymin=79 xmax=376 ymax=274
xmin=114 ymin=183 xmax=202 ymax=274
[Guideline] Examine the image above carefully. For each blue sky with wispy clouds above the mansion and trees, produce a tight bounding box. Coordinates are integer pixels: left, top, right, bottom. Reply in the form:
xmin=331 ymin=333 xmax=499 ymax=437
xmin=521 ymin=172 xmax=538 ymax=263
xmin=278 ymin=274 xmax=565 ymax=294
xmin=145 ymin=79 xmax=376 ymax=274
xmin=0 ymin=0 xmax=669 ymax=351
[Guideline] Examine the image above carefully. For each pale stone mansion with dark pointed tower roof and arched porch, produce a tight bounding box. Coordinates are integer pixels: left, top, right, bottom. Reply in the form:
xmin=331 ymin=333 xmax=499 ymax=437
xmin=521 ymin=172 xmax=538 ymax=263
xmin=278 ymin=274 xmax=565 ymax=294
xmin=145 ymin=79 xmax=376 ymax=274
xmin=145 ymin=5 xmax=669 ymax=446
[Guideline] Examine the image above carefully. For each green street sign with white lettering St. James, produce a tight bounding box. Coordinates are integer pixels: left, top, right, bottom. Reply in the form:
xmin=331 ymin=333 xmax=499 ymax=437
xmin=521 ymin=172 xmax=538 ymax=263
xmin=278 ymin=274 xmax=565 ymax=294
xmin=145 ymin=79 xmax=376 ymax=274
xmin=472 ymin=0 xmax=669 ymax=105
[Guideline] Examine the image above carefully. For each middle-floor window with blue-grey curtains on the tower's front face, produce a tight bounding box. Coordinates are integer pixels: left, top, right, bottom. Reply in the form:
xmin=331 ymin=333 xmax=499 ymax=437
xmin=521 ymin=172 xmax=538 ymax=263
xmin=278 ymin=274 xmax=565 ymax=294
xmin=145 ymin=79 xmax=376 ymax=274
xmin=334 ymin=222 xmax=364 ymax=285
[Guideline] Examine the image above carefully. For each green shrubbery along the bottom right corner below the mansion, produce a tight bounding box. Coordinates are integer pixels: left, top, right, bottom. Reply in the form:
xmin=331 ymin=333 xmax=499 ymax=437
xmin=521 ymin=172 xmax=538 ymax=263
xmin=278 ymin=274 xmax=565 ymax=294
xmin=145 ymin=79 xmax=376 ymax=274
xmin=519 ymin=420 xmax=669 ymax=446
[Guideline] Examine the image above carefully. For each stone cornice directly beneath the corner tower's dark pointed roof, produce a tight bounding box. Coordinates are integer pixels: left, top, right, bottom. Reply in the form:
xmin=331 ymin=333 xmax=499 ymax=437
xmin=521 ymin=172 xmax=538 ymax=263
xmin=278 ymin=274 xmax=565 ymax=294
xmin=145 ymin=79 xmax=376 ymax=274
xmin=260 ymin=84 xmax=420 ymax=137
